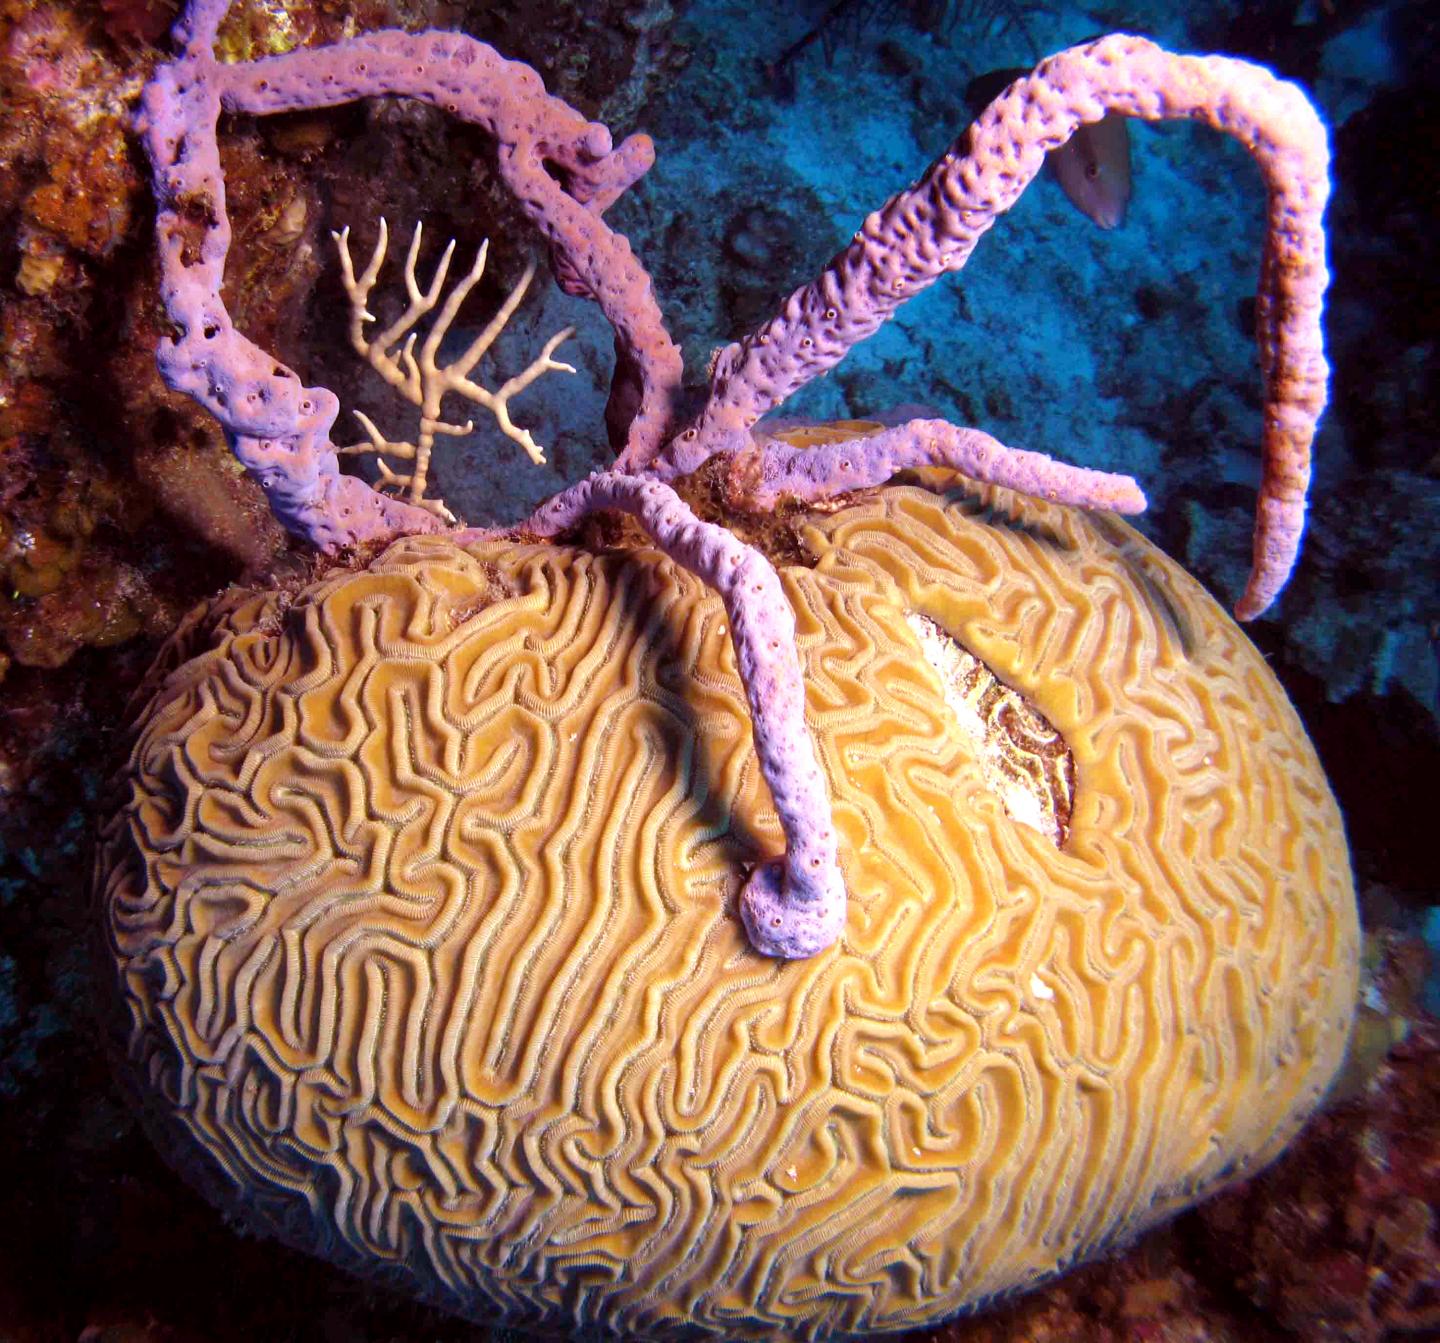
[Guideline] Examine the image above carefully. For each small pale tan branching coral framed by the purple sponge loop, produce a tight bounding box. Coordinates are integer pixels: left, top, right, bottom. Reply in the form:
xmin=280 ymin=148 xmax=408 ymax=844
xmin=331 ymin=219 xmax=575 ymax=523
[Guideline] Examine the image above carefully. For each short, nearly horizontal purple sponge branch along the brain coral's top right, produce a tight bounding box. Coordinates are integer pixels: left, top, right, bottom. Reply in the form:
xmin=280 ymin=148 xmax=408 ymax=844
xmin=736 ymin=420 xmax=1145 ymax=512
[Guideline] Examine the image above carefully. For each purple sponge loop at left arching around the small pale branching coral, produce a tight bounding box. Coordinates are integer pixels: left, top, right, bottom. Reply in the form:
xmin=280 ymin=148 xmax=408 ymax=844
xmin=137 ymin=0 xmax=681 ymax=551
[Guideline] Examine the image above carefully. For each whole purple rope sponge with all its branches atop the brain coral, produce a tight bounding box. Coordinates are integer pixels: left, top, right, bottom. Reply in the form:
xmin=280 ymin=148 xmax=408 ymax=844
xmin=138 ymin=0 xmax=1329 ymax=957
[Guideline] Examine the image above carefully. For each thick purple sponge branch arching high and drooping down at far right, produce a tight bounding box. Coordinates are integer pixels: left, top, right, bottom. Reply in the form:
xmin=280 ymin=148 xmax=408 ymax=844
xmin=685 ymin=35 xmax=1329 ymax=619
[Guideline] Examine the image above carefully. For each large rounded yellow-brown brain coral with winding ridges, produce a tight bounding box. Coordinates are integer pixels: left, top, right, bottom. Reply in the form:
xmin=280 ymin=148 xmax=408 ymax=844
xmin=98 ymin=487 xmax=1356 ymax=1337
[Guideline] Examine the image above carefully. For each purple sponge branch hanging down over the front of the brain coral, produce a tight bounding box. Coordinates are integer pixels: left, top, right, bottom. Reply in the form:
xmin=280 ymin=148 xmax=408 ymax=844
xmin=524 ymin=471 xmax=845 ymax=957
